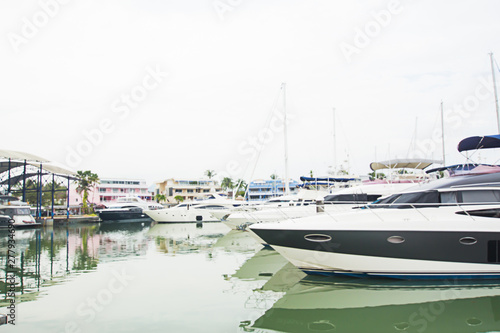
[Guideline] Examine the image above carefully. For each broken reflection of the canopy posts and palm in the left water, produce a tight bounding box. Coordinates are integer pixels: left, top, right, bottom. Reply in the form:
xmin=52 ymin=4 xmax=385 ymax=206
xmin=0 ymin=224 xmax=149 ymax=307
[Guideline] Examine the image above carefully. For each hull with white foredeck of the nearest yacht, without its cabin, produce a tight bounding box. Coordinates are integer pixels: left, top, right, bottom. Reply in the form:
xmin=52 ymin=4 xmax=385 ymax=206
xmin=250 ymin=205 xmax=500 ymax=279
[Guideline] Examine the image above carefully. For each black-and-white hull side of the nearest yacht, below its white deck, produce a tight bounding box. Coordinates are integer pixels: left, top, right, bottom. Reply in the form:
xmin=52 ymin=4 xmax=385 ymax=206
xmin=251 ymin=225 xmax=500 ymax=279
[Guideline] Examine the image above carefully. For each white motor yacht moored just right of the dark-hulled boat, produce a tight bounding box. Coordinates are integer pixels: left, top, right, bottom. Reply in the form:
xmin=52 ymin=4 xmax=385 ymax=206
xmin=144 ymin=193 xmax=242 ymax=223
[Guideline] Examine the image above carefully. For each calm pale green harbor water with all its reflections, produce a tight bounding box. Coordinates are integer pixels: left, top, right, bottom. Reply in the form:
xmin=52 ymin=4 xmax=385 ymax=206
xmin=0 ymin=223 xmax=500 ymax=332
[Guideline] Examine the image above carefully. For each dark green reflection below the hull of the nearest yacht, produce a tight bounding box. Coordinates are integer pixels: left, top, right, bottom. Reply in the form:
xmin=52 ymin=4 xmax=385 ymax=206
xmin=250 ymin=277 xmax=500 ymax=333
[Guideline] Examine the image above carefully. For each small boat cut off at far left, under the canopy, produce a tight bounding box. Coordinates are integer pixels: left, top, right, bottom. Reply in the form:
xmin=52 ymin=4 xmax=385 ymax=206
xmin=0 ymin=195 xmax=41 ymax=228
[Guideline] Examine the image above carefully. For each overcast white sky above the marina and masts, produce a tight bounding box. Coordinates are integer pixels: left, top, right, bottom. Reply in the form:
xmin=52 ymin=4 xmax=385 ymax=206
xmin=0 ymin=0 xmax=500 ymax=183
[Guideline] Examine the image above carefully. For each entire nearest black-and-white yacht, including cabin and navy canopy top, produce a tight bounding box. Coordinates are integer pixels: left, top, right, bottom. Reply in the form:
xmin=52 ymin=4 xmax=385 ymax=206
xmin=250 ymin=136 xmax=500 ymax=279
